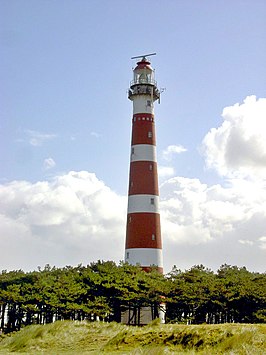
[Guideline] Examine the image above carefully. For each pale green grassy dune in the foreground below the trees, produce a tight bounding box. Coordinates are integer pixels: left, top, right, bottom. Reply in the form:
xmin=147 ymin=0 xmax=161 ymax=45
xmin=0 ymin=321 xmax=266 ymax=355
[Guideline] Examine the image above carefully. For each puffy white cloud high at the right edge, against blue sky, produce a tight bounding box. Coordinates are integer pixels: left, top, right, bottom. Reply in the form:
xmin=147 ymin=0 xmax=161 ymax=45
xmin=203 ymin=96 xmax=266 ymax=179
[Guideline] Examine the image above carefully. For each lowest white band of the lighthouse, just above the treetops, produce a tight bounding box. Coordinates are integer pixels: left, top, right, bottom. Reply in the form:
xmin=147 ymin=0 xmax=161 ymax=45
xmin=125 ymin=248 xmax=163 ymax=267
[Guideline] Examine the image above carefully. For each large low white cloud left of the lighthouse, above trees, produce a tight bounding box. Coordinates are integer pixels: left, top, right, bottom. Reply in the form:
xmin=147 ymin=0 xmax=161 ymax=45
xmin=0 ymin=171 xmax=126 ymax=269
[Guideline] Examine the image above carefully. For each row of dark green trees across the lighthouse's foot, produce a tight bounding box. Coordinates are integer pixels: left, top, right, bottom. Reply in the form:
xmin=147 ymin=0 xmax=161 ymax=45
xmin=0 ymin=261 xmax=266 ymax=332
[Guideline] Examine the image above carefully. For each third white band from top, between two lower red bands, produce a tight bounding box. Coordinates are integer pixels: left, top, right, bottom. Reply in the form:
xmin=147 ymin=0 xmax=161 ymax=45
xmin=127 ymin=194 xmax=159 ymax=213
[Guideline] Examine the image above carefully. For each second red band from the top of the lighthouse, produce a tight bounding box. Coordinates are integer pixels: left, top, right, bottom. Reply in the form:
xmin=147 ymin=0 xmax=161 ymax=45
xmin=128 ymin=161 xmax=159 ymax=195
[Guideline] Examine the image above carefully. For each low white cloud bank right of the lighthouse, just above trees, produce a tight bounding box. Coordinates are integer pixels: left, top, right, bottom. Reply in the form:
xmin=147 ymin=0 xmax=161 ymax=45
xmin=160 ymin=177 xmax=266 ymax=271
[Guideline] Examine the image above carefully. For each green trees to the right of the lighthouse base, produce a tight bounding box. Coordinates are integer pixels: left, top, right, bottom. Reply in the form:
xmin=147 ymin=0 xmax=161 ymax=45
xmin=166 ymin=265 xmax=266 ymax=324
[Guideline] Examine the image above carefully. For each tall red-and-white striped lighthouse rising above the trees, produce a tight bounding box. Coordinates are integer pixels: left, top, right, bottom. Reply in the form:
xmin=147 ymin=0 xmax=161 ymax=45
xmin=125 ymin=55 xmax=163 ymax=273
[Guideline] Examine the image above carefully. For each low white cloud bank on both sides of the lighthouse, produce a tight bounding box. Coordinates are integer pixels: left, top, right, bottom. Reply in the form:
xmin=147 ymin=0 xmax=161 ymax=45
xmin=0 ymin=171 xmax=266 ymax=271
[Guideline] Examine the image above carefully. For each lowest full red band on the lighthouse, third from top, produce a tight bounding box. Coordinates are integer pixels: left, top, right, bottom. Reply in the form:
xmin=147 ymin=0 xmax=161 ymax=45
xmin=126 ymin=213 xmax=162 ymax=249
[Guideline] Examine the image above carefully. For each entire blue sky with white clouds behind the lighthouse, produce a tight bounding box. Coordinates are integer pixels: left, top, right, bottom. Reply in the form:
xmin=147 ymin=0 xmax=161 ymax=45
xmin=0 ymin=0 xmax=266 ymax=272
